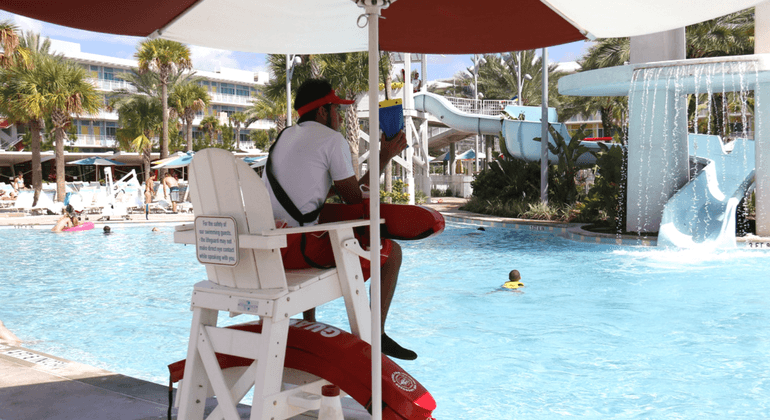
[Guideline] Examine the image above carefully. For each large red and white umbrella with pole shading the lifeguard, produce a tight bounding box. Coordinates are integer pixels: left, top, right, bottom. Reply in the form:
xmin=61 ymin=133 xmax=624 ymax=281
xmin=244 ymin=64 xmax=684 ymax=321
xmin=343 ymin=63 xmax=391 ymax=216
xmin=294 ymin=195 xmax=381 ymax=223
xmin=7 ymin=0 xmax=764 ymax=420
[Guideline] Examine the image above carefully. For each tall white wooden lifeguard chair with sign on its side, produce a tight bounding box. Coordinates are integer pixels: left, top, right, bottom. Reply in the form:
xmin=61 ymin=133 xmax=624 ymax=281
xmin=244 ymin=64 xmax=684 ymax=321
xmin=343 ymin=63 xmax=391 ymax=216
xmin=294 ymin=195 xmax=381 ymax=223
xmin=174 ymin=149 xmax=371 ymax=420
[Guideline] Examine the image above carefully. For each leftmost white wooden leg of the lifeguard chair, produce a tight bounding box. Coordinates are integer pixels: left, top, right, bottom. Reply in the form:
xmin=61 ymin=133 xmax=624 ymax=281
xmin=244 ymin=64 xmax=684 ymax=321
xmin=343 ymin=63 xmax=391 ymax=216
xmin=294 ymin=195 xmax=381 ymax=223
xmin=178 ymin=308 xmax=218 ymax=420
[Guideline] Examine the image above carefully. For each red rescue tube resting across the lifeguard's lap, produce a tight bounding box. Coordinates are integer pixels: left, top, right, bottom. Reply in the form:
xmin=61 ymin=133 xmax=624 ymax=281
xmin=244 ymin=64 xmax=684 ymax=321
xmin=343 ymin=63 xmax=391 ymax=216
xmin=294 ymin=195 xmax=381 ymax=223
xmin=319 ymin=204 xmax=445 ymax=240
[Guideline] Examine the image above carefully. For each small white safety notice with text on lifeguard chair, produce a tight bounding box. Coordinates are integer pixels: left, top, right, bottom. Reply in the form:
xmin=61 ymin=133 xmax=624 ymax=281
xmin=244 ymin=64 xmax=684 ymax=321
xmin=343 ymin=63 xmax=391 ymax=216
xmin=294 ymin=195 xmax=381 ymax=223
xmin=195 ymin=216 xmax=238 ymax=267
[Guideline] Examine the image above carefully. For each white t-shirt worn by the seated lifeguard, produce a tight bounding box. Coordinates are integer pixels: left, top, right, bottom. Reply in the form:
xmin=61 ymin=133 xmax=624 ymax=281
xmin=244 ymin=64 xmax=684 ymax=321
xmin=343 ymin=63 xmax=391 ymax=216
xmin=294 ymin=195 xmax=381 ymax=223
xmin=262 ymin=121 xmax=355 ymax=227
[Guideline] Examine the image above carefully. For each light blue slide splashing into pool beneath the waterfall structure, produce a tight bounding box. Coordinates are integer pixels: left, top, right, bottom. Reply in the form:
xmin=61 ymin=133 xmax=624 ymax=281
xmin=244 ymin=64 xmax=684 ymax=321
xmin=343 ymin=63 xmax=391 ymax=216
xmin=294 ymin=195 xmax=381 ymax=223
xmin=658 ymin=134 xmax=754 ymax=248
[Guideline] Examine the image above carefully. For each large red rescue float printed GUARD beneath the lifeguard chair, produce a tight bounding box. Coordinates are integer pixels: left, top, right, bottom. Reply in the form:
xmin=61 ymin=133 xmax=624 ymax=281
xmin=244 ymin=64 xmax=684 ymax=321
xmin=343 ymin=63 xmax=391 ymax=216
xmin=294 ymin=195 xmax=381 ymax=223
xmin=169 ymin=320 xmax=436 ymax=420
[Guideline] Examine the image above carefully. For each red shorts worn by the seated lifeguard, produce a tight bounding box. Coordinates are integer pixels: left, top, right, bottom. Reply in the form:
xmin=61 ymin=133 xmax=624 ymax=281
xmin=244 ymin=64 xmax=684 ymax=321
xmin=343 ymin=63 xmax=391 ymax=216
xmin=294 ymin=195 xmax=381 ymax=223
xmin=281 ymin=228 xmax=393 ymax=280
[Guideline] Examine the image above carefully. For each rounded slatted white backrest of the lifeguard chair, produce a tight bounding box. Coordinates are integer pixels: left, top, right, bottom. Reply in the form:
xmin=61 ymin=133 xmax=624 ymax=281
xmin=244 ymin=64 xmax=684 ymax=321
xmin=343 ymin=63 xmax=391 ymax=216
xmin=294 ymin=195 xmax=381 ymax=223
xmin=190 ymin=148 xmax=287 ymax=289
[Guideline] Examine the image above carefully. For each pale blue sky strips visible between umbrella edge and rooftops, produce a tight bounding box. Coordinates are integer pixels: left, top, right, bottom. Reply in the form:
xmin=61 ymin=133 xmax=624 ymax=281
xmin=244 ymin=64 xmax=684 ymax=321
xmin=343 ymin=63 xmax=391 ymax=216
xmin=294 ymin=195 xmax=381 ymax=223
xmin=0 ymin=10 xmax=591 ymax=80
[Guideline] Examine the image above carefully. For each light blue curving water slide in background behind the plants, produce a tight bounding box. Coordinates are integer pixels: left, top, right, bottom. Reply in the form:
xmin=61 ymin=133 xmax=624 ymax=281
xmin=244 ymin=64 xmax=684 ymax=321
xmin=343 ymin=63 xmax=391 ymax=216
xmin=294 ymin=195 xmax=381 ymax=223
xmin=414 ymin=93 xmax=599 ymax=164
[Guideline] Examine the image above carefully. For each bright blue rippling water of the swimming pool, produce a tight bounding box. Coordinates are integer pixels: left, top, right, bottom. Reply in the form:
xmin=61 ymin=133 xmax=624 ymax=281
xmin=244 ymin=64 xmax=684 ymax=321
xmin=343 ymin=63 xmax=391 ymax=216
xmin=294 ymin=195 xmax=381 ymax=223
xmin=0 ymin=224 xmax=770 ymax=420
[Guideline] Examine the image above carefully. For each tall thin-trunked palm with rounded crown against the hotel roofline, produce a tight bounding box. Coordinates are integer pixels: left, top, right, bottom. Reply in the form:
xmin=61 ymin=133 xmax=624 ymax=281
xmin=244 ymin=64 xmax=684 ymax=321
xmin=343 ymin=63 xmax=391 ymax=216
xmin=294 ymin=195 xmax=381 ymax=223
xmin=134 ymin=38 xmax=192 ymax=172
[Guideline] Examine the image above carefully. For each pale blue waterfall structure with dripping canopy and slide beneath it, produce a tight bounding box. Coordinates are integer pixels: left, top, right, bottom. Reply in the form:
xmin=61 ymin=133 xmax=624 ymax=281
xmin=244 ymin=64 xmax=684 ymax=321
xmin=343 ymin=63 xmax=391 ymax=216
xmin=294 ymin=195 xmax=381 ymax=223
xmin=559 ymin=54 xmax=770 ymax=247
